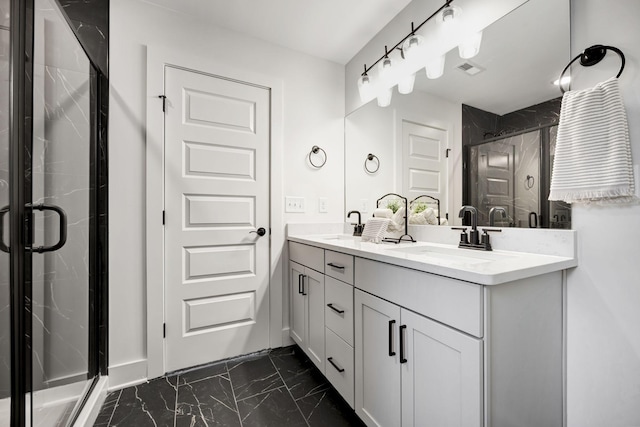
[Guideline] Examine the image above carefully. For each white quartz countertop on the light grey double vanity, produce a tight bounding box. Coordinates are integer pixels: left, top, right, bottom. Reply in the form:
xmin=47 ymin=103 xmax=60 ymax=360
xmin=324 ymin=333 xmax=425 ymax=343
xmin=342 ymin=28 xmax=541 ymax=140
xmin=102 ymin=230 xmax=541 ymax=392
xmin=288 ymin=234 xmax=578 ymax=285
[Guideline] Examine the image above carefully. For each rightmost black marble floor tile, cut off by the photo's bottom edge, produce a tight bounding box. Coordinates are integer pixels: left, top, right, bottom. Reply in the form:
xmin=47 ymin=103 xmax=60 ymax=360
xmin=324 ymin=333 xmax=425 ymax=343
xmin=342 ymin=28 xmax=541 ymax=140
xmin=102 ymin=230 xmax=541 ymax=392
xmin=296 ymin=389 xmax=365 ymax=427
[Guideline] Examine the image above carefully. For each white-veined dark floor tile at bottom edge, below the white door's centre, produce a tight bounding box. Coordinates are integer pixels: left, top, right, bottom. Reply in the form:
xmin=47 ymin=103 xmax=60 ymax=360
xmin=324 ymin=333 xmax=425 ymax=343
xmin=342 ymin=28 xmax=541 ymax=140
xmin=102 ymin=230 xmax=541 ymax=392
xmin=176 ymin=375 xmax=240 ymax=427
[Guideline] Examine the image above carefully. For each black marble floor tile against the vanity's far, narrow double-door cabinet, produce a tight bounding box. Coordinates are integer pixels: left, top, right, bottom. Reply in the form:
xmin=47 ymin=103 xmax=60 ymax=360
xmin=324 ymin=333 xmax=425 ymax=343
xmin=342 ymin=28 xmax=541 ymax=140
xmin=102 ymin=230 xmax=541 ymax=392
xmin=270 ymin=346 xmax=330 ymax=400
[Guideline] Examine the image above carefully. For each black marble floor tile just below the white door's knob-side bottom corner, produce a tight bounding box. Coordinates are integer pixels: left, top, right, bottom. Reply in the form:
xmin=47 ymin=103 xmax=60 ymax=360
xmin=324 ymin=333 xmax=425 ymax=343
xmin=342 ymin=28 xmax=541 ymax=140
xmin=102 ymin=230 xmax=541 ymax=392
xmin=227 ymin=353 xmax=284 ymax=400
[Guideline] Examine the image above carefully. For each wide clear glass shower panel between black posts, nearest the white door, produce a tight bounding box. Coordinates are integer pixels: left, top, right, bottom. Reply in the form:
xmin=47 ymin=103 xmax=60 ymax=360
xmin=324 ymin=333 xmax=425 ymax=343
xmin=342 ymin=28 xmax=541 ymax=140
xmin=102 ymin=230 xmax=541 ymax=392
xmin=27 ymin=0 xmax=93 ymax=426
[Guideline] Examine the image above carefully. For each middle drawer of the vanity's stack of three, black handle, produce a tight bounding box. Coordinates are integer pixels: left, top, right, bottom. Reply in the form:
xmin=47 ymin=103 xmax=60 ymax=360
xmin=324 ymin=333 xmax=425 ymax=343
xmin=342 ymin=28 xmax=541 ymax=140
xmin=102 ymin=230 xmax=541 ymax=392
xmin=324 ymin=276 xmax=353 ymax=346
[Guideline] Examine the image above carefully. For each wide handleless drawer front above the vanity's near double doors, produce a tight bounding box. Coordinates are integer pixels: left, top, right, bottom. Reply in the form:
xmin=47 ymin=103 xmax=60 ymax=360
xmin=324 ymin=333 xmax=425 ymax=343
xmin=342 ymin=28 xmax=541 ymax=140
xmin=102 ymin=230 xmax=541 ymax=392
xmin=355 ymin=258 xmax=484 ymax=338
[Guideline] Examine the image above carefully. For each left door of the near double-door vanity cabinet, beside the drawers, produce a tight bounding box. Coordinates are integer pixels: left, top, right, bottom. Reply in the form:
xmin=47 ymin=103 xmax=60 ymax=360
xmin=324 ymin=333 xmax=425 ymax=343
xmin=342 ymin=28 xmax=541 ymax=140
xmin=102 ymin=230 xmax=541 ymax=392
xmin=355 ymin=289 xmax=401 ymax=427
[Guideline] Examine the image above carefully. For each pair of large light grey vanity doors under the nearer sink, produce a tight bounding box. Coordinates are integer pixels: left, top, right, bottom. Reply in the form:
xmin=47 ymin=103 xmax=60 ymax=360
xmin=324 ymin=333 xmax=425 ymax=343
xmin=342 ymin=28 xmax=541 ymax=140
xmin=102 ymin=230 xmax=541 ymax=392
xmin=355 ymin=289 xmax=482 ymax=427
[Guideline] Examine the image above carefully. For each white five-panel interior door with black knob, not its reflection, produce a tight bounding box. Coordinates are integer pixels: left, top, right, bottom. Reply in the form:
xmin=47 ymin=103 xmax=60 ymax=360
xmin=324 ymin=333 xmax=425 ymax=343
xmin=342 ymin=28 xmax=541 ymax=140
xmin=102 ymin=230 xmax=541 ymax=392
xmin=162 ymin=67 xmax=270 ymax=371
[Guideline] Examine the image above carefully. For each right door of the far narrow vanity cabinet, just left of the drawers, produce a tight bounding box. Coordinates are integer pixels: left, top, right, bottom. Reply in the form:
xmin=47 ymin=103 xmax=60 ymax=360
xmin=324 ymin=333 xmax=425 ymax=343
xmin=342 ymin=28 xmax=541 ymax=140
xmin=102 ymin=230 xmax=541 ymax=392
xmin=303 ymin=268 xmax=325 ymax=373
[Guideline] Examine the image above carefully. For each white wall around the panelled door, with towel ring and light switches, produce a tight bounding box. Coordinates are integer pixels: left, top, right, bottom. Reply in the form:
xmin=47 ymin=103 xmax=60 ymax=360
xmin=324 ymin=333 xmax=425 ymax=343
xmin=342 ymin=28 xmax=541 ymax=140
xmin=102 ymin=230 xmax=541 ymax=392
xmin=109 ymin=0 xmax=344 ymax=387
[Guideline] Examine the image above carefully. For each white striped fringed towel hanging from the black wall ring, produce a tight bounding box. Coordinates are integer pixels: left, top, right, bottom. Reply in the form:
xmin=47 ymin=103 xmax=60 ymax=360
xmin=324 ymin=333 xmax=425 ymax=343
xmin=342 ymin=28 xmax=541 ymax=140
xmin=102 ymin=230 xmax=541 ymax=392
xmin=549 ymin=77 xmax=635 ymax=203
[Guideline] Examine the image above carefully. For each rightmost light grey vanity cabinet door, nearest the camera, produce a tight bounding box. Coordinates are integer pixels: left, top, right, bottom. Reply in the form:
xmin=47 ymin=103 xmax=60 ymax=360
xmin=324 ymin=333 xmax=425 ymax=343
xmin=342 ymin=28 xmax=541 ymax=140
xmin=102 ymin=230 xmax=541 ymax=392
xmin=401 ymin=309 xmax=482 ymax=427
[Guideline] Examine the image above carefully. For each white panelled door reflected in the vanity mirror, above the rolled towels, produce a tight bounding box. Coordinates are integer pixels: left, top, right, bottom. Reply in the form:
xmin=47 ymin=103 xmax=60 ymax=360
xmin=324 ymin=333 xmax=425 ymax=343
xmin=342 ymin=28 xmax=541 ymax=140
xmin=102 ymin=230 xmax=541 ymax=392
xmin=402 ymin=120 xmax=449 ymax=218
